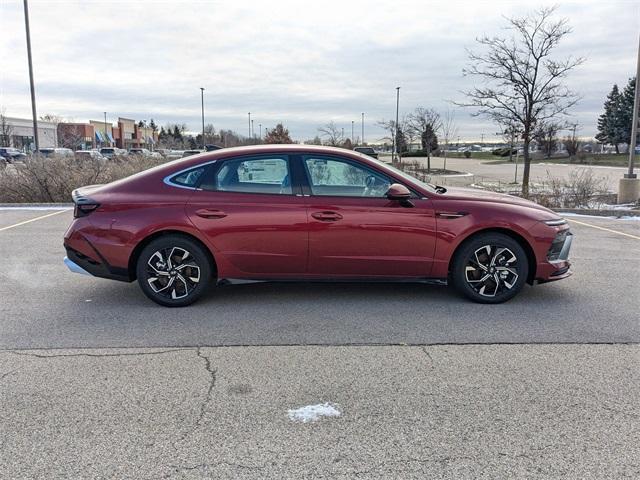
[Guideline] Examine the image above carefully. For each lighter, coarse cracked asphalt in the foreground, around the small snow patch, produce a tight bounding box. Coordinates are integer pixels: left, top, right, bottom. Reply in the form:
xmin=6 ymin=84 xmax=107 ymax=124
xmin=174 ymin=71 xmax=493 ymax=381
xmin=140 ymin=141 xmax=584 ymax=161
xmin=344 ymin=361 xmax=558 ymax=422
xmin=0 ymin=345 xmax=640 ymax=480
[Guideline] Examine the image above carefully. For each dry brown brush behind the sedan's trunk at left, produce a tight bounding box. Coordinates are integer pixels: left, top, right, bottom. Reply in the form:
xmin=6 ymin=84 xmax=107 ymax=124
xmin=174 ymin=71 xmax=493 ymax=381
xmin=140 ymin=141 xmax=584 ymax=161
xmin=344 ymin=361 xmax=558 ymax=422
xmin=0 ymin=156 xmax=165 ymax=203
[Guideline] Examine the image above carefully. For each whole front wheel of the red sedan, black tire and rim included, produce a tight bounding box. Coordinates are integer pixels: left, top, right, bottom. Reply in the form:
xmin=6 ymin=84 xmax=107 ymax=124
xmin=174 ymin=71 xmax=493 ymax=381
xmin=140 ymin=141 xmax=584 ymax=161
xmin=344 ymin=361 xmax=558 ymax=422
xmin=451 ymin=233 xmax=529 ymax=303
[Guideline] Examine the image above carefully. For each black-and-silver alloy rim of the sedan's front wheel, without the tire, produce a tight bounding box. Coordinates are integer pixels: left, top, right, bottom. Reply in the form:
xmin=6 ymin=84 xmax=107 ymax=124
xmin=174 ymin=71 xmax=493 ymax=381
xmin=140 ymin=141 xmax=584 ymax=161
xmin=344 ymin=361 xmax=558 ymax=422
xmin=465 ymin=245 xmax=519 ymax=297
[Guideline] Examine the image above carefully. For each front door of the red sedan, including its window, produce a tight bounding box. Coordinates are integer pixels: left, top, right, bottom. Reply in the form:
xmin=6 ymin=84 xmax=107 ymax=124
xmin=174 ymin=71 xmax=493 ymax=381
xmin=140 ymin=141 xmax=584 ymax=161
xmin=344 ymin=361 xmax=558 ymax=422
xmin=301 ymin=154 xmax=435 ymax=278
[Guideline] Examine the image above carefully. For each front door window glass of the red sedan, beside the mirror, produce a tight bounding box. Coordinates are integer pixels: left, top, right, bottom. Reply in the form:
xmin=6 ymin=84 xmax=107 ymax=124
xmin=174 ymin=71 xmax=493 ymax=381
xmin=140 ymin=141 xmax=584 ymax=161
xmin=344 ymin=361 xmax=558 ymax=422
xmin=304 ymin=156 xmax=391 ymax=197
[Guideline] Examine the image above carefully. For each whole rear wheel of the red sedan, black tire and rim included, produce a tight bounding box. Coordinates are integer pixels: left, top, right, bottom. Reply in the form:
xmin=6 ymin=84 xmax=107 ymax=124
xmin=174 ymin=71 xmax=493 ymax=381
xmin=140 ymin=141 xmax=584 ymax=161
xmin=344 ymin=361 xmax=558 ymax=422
xmin=136 ymin=235 xmax=212 ymax=307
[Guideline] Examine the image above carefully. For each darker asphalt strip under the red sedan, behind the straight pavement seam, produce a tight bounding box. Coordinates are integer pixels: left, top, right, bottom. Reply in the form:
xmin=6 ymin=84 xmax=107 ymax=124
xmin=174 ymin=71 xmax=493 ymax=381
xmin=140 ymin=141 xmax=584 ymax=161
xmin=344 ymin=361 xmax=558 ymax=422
xmin=0 ymin=210 xmax=640 ymax=349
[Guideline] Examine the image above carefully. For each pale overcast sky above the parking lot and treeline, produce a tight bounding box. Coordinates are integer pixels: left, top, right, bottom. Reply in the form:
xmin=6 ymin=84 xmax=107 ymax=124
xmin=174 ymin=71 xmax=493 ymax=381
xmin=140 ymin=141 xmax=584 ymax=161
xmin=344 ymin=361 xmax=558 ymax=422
xmin=0 ymin=0 xmax=640 ymax=141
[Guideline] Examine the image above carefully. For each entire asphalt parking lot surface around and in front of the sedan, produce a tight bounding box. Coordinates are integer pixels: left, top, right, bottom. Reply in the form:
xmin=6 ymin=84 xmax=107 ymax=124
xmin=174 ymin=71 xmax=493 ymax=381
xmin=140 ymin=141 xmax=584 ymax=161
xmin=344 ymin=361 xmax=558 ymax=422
xmin=0 ymin=209 xmax=640 ymax=480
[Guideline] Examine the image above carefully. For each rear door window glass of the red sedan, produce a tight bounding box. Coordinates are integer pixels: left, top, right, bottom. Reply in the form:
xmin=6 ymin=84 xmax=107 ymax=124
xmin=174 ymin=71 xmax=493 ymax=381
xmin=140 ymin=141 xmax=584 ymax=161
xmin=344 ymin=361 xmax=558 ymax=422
xmin=215 ymin=157 xmax=293 ymax=195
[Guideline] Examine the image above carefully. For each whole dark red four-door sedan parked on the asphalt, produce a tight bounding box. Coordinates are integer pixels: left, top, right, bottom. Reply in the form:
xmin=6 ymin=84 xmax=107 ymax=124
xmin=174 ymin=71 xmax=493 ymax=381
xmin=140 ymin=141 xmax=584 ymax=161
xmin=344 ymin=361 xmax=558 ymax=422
xmin=64 ymin=145 xmax=572 ymax=306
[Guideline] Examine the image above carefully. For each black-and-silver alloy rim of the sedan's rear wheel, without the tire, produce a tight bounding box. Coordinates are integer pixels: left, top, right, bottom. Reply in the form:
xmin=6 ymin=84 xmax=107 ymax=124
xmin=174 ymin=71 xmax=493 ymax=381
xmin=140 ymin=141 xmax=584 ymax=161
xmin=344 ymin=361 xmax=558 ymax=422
xmin=145 ymin=247 xmax=200 ymax=300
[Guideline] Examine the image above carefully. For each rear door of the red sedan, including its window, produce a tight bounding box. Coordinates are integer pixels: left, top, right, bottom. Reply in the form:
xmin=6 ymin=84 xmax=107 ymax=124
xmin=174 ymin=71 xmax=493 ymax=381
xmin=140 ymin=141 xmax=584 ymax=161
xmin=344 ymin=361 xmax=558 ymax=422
xmin=186 ymin=154 xmax=308 ymax=278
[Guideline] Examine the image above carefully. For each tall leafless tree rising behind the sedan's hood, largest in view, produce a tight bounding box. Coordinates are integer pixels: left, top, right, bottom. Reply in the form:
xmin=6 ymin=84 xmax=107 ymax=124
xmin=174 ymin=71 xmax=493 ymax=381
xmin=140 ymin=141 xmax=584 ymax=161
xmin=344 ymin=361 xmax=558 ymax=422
xmin=458 ymin=7 xmax=584 ymax=197
